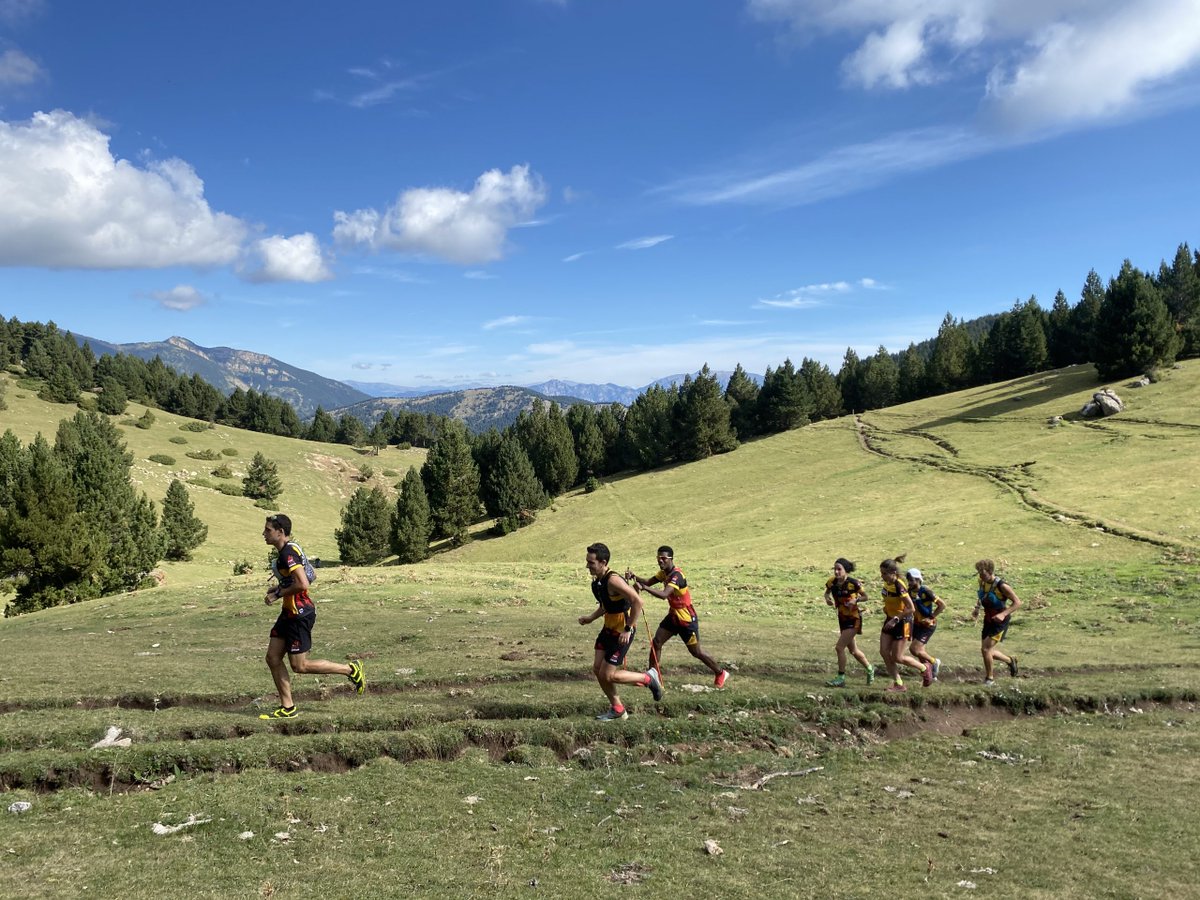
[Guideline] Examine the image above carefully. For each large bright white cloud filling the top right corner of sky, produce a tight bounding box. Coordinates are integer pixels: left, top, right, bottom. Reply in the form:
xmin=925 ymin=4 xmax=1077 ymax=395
xmin=748 ymin=0 xmax=1200 ymax=130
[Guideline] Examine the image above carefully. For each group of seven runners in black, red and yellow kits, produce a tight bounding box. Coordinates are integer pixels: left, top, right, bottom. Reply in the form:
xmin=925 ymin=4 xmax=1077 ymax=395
xmin=259 ymin=514 xmax=1021 ymax=721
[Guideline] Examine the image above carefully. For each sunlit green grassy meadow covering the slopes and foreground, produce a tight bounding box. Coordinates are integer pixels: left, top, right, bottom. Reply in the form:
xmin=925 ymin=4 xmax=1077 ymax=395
xmin=0 ymin=360 xmax=1200 ymax=898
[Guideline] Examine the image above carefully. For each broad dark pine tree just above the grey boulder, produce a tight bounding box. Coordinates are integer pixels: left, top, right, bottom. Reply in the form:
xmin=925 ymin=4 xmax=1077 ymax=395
xmin=1096 ymin=259 xmax=1183 ymax=382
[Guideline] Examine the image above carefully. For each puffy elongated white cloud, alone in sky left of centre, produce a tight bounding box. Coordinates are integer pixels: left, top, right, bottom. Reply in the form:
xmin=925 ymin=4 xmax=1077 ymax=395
xmin=334 ymin=166 xmax=546 ymax=265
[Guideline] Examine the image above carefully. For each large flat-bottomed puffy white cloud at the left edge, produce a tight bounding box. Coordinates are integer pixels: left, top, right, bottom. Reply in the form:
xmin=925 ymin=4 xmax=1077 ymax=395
xmin=0 ymin=110 xmax=247 ymax=269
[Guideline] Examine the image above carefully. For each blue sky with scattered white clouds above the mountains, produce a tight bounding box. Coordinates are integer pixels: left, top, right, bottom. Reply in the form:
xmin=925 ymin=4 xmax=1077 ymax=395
xmin=0 ymin=0 xmax=1200 ymax=385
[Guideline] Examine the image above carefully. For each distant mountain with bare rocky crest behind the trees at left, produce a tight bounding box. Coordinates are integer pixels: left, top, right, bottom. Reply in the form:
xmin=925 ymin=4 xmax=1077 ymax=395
xmin=76 ymin=335 xmax=367 ymax=418
